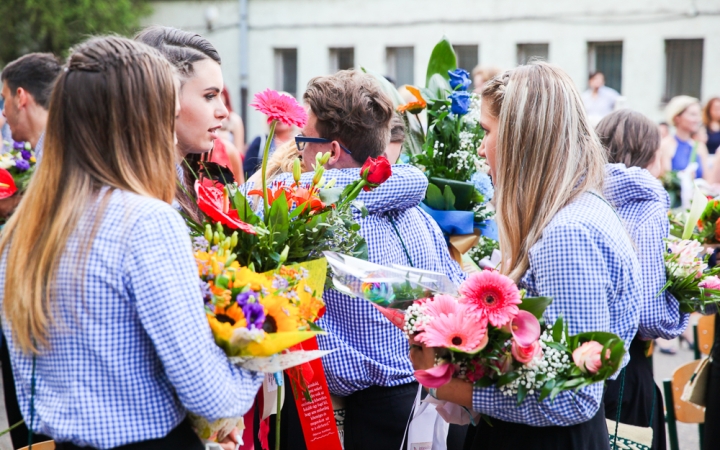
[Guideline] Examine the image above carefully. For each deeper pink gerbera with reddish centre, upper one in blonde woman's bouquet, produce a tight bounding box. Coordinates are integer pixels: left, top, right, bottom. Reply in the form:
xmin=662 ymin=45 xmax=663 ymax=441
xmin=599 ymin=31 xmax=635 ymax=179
xmin=460 ymin=270 xmax=521 ymax=327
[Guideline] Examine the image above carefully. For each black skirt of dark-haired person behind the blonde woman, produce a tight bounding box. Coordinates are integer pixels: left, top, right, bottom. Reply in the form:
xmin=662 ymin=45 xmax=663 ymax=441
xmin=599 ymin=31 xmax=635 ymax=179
xmin=604 ymin=336 xmax=666 ymax=450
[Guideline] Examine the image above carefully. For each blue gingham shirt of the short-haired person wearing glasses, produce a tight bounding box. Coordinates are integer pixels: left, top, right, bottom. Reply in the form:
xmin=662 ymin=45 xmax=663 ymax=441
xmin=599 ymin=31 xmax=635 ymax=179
xmin=272 ymin=164 xmax=465 ymax=396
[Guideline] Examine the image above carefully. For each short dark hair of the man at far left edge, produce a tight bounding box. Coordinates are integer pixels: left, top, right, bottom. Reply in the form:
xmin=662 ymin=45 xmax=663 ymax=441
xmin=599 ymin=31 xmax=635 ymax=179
xmin=0 ymin=53 xmax=61 ymax=109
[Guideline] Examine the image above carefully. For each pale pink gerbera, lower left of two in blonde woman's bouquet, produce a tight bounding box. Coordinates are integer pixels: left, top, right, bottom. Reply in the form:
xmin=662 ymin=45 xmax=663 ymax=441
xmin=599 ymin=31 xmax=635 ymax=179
xmin=415 ymin=310 xmax=488 ymax=353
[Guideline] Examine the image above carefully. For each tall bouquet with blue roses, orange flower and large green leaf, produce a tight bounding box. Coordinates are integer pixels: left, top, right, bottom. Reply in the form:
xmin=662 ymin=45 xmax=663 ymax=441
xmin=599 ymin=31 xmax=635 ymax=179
xmin=362 ymin=39 xmax=498 ymax=264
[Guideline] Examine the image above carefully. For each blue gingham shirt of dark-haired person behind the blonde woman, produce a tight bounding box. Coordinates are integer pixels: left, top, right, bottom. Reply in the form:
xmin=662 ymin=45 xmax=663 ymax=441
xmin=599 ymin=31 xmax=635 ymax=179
xmin=603 ymin=164 xmax=690 ymax=339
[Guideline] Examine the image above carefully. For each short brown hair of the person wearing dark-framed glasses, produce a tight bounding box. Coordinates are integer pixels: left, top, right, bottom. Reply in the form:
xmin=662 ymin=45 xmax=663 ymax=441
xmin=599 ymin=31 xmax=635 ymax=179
xmin=303 ymin=70 xmax=395 ymax=164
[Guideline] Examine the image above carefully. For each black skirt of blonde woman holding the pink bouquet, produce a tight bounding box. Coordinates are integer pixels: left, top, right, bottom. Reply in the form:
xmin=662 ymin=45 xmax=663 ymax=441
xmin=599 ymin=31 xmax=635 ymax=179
xmin=464 ymin=404 xmax=610 ymax=450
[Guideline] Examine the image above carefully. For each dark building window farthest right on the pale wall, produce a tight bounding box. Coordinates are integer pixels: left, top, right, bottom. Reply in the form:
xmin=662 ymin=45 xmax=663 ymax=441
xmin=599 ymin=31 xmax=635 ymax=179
xmin=663 ymin=39 xmax=703 ymax=101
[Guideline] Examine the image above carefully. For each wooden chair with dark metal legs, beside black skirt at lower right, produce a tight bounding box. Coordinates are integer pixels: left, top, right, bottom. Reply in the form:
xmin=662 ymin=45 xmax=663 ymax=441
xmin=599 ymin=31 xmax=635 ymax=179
xmin=663 ymin=361 xmax=705 ymax=450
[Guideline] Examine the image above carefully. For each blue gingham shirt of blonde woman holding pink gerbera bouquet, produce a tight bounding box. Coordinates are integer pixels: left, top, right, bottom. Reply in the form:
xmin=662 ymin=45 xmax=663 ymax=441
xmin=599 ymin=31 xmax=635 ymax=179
xmin=473 ymin=193 xmax=642 ymax=426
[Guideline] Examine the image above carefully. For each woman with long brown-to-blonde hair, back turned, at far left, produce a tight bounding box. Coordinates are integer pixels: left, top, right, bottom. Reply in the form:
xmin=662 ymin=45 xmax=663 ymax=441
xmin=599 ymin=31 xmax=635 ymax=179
xmin=0 ymin=37 xmax=261 ymax=450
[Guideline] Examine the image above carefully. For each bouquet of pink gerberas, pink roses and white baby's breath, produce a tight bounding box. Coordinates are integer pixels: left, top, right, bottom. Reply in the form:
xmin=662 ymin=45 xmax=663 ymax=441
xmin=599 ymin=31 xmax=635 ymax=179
xmin=328 ymin=255 xmax=625 ymax=404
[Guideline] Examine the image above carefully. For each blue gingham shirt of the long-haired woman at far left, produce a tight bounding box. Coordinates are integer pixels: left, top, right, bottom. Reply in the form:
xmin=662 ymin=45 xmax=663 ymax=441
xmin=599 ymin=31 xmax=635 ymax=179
xmin=0 ymin=190 xmax=262 ymax=449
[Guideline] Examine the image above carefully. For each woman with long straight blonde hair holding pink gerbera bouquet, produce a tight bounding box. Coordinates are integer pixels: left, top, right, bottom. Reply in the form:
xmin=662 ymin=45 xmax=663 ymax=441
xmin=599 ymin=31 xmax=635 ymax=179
xmin=410 ymin=62 xmax=641 ymax=450
